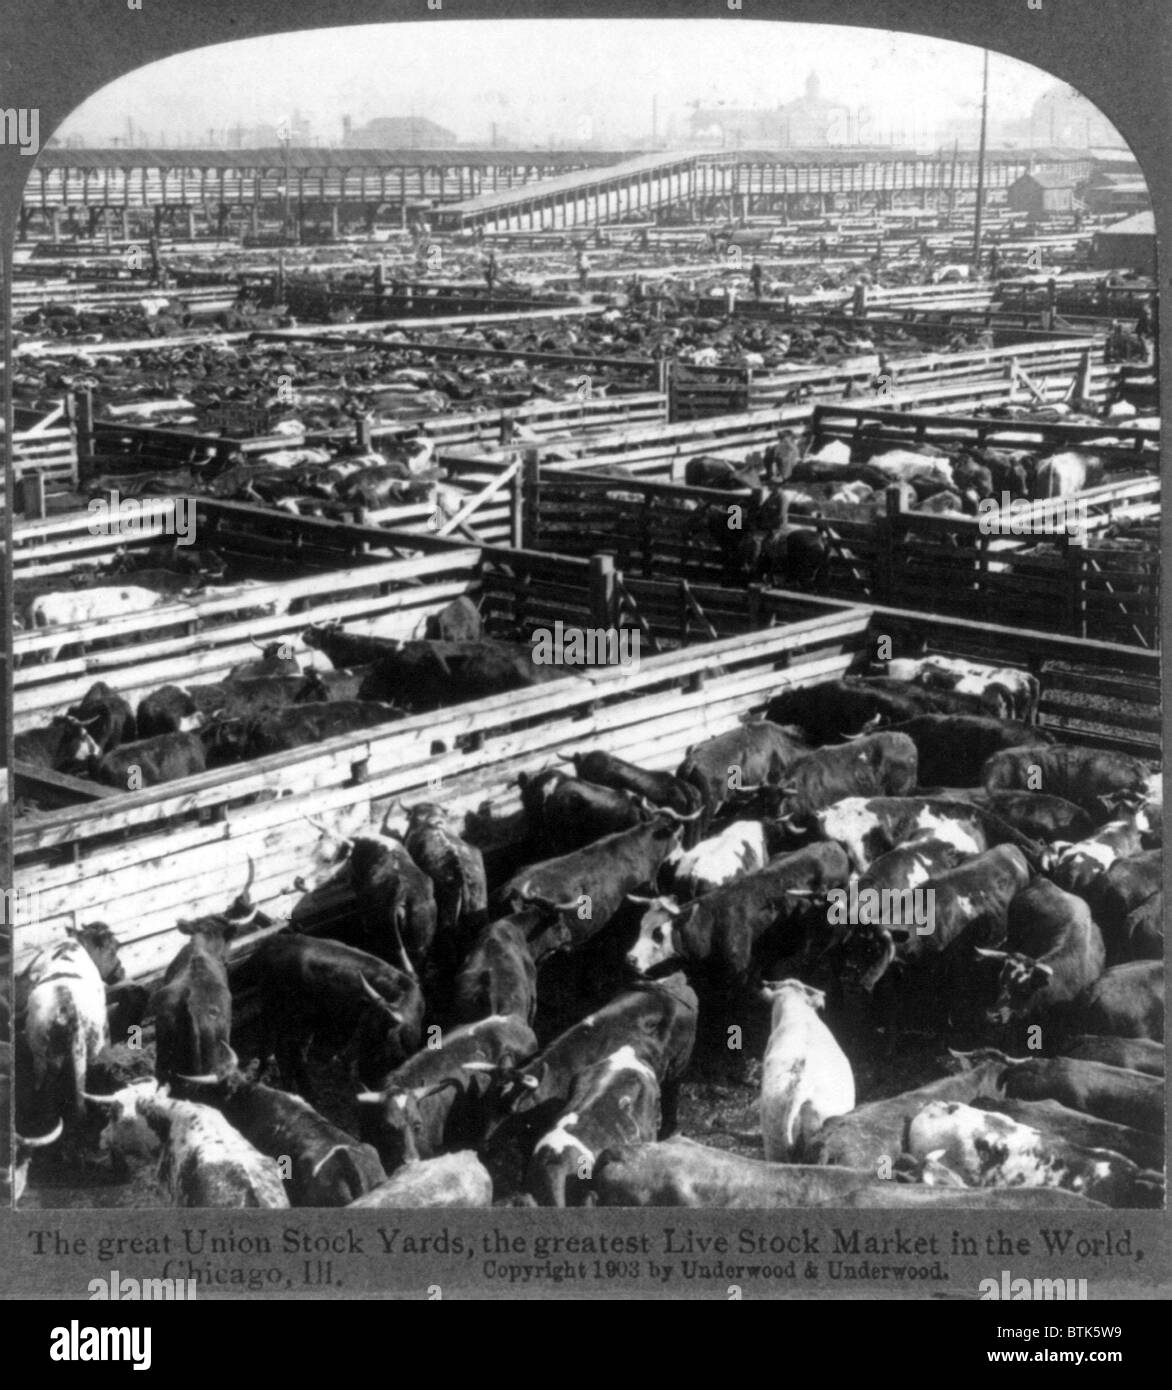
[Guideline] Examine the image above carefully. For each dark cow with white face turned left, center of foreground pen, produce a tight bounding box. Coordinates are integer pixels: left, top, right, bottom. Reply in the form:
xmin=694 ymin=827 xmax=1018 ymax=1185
xmin=626 ymin=842 xmax=849 ymax=991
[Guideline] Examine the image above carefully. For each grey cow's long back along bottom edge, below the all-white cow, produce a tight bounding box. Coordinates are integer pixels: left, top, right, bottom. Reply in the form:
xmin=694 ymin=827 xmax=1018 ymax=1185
xmin=594 ymin=1136 xmax=1101 ymax=1211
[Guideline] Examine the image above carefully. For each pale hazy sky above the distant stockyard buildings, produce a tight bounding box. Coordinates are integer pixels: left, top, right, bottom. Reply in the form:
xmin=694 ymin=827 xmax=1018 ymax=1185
xmin=58 ymin=18 xmax=1089 ymax=143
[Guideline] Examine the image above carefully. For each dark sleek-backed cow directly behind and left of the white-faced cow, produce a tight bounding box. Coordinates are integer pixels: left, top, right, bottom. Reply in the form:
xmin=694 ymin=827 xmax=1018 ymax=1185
xmin=499 ymin=816 xmax=680 ymax=963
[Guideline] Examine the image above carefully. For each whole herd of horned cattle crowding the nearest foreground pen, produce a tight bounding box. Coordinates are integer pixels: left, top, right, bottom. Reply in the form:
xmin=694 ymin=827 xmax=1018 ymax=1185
xmin=15 ymin=650 xmax=1164 ymax=1208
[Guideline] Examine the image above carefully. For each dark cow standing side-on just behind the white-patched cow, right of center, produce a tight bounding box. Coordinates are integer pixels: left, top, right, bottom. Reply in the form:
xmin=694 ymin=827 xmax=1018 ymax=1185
xmin=763 ymin=733 xmax=916 ymax=834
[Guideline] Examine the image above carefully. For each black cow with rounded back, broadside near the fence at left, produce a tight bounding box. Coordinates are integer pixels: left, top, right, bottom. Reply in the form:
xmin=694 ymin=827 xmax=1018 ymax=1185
xmin=246 ymin=931 xmax=423 ymax=1094
